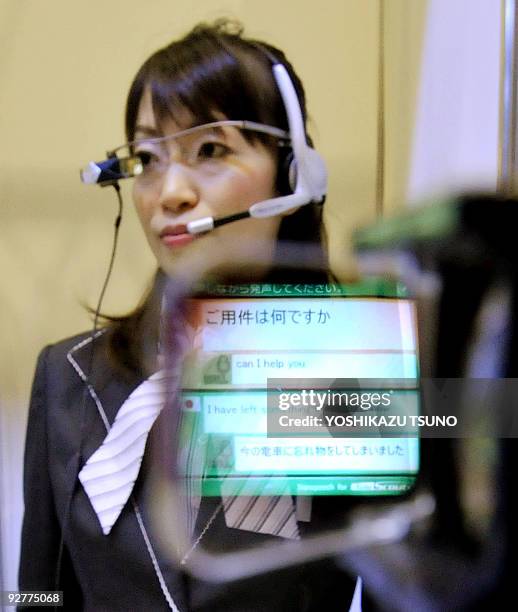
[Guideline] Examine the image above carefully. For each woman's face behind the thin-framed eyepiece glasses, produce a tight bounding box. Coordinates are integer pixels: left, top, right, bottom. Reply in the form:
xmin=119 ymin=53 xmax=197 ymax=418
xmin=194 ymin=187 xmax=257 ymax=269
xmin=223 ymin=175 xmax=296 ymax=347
xmin=133 ymin=90 xmax=280 ymax=274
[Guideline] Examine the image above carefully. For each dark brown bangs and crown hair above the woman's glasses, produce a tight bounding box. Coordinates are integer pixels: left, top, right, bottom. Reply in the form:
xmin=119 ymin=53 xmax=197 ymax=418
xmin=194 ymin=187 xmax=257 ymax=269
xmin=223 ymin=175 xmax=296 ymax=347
xmin=126 ymin=20 xmax=306 ymax=141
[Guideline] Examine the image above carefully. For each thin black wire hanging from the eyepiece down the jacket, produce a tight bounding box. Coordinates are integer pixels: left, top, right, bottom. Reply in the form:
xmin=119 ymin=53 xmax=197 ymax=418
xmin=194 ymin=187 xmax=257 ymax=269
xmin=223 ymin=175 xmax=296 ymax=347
xmin=54 ymin=183 xmax=123 ymax=610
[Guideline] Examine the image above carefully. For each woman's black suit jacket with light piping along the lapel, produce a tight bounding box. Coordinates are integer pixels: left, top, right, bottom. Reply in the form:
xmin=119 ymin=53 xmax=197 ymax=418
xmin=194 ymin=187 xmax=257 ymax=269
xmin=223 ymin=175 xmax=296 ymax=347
xmin=19 ymin=334 xmax=353 ymax=612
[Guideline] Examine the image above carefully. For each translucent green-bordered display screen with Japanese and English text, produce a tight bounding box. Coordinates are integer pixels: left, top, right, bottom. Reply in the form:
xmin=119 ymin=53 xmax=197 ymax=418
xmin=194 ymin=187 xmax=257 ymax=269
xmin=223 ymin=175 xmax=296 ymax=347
xmin=177 ymin=285 xmax=419 ymax=496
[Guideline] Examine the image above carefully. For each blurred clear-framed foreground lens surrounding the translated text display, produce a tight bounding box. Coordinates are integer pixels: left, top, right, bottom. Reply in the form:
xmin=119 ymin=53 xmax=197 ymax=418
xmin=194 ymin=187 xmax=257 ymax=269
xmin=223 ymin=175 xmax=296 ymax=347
xmin=146 ymin=243 xmax=434 ymax=582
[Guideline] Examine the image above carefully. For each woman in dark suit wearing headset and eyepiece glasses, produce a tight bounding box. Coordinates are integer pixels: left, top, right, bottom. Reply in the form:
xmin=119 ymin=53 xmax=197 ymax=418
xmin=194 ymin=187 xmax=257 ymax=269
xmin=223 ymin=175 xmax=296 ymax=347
xmin=20 ymin=23 xmax=358 ymax=611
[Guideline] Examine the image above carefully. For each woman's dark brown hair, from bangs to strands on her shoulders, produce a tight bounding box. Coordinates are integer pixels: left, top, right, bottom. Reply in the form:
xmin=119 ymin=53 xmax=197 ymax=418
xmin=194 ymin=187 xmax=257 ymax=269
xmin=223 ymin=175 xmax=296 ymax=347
xmin=109 ymin=20 xmax=325 ymax=378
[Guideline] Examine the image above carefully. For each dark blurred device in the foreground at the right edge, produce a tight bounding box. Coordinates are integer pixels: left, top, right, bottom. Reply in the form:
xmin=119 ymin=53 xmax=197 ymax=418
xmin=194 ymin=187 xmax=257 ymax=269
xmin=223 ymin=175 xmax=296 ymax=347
xmin=350 ymin=194 xmax=518 ymax=611
